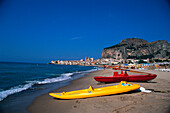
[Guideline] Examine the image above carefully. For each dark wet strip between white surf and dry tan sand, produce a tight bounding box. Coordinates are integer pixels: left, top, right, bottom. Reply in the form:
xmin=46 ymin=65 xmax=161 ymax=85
xmin=0 ymin=65 xmax=96 ymax=113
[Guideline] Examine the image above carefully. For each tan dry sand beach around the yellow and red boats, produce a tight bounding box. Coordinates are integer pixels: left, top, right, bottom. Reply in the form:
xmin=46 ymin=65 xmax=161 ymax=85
xmin=27 ymin=69 xmax=170 ymax=113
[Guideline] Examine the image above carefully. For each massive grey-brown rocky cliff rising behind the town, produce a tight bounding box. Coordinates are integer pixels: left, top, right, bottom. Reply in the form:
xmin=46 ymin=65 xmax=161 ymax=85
xmin=102 ymin=38 xmax=170 ymax=59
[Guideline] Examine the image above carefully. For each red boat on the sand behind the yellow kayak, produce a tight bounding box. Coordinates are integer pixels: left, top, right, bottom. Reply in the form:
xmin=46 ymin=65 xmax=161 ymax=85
xmin=94 ymin=71 xmax=157 ymax=82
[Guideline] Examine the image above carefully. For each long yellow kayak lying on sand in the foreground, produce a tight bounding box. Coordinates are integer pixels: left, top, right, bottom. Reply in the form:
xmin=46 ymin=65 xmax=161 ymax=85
xmin=49 ymin=81 xmax=140 ymax=99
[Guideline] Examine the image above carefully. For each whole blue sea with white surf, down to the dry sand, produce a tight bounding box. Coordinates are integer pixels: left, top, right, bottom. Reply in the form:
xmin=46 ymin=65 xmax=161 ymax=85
xmin=0 ymin=62 xmax=97 ymax=113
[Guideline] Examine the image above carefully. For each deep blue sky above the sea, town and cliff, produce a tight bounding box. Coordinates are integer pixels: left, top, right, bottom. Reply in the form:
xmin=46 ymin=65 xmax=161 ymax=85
xmin=0 ymin=0 xmax=170 ymax=62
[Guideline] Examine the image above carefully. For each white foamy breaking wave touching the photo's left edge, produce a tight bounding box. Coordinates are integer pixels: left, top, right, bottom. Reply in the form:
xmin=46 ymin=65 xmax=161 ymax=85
xmin=0 ymin=83 xmax=33 ymax=101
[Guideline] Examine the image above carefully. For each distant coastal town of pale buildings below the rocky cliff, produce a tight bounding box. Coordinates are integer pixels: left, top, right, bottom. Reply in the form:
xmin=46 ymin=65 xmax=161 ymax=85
xmin=50 ymin=57 xmax=170 ymax=69
